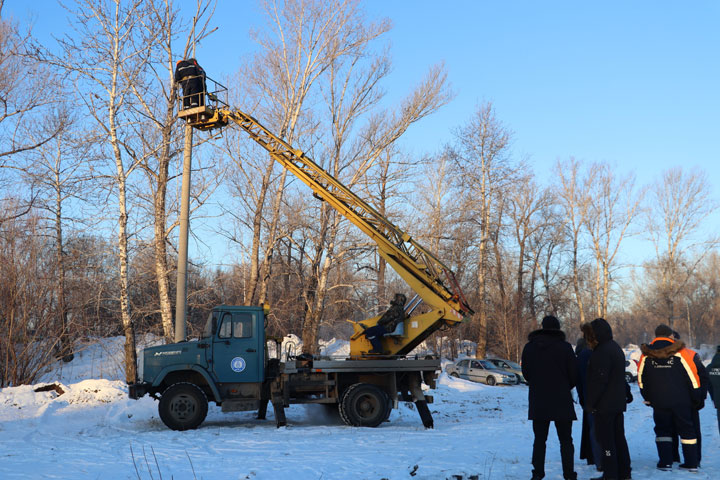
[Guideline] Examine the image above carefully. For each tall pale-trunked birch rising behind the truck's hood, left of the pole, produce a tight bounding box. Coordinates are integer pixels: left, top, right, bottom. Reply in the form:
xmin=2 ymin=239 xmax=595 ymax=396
xmin=44 ymin=0 xmax=161 ymax=383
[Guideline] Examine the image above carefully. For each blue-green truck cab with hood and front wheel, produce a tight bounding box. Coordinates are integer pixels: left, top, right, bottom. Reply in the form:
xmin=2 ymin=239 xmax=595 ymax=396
xmin=129 ymin=305 xmax=267 ymax=430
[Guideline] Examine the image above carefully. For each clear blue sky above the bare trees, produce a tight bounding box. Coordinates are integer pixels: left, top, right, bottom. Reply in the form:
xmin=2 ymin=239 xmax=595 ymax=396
xmin=4 ymin=0 xmax=720 ymax=266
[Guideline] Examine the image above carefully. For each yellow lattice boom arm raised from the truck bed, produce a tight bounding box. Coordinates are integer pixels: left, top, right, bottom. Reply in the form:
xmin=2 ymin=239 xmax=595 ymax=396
xmin=179 ymin=101 xmax=473 ymax=356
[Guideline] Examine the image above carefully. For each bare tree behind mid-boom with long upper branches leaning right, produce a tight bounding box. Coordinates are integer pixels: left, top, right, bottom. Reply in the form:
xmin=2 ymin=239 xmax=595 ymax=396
xmin=302 ymin=33 xmax=449 ymax=353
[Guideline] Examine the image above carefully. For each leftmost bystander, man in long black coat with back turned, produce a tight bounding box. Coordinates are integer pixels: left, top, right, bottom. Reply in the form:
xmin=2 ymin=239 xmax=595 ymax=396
xmin=522 ymin=316 xmax=577 ymax=480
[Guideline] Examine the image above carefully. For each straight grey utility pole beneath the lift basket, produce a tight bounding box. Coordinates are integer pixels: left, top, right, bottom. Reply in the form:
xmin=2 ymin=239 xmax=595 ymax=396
xmin=175 ymin=123 xmax=193 ymax=342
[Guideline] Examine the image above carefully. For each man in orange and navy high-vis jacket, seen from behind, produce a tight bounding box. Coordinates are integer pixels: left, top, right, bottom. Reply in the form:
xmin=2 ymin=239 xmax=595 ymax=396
xmin=638 ymin=325 xmax=706 ymax=471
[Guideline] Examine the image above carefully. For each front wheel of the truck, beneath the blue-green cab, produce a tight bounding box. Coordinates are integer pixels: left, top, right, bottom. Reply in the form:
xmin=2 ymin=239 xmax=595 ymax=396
xmin=158 ymin=382 xmax=207 ymax=430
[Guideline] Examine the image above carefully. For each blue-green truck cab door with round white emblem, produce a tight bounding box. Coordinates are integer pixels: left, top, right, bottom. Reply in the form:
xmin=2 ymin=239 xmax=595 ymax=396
xmin=212 ymin=312 xmax=264 ymax=383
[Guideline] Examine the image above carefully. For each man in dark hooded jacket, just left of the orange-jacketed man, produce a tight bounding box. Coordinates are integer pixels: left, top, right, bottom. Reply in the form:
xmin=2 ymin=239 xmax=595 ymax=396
xmin=582 ymin=318 xmax=631 ymax=479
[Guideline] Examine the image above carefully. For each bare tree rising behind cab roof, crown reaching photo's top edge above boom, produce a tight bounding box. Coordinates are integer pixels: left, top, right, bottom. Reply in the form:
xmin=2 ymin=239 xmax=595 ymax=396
xmin=235 ymin=0 xmax=388 ymax=303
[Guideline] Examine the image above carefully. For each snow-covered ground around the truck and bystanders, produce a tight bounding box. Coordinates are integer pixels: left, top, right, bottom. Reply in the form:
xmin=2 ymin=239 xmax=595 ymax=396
xmin=0 ymin=340 xmax=720 ymax=480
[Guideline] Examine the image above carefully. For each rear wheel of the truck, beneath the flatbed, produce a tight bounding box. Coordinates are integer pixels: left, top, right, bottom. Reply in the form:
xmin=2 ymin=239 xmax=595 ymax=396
xmin=339 ymin=383 xmax=390 ymax=427
